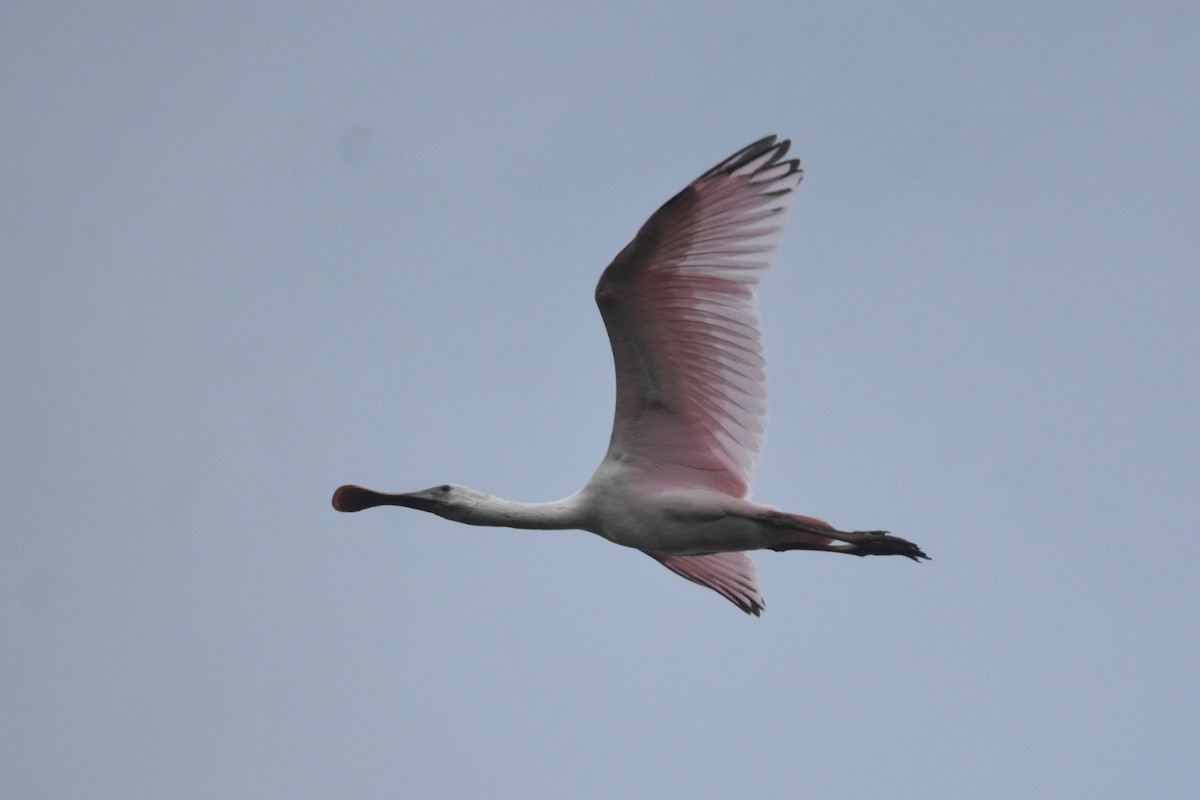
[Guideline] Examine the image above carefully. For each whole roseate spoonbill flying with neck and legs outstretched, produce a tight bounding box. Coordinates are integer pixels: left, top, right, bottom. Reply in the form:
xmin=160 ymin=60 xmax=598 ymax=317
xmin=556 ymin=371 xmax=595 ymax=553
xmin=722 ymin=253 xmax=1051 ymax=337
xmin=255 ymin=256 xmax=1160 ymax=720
xmin=332 ymin=136 xmax=929 ymax=615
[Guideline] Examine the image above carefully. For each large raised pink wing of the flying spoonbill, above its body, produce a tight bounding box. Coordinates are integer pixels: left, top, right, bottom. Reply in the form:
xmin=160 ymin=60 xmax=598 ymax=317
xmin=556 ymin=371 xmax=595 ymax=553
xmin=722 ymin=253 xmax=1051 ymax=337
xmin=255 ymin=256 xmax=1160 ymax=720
xmin=596 ymin=137 xmax=803 ymax=501
